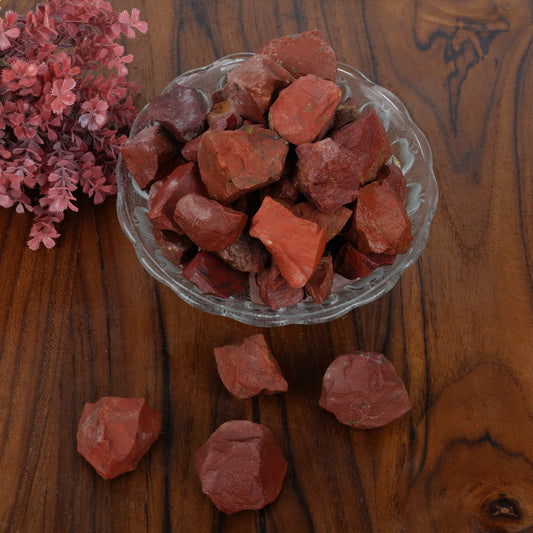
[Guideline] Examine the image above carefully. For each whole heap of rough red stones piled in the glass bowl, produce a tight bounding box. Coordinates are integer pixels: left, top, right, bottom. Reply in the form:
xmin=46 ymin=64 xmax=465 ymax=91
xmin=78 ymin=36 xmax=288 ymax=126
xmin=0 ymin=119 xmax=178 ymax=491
xmin=121 ymin=30 xmax=412 ymax=309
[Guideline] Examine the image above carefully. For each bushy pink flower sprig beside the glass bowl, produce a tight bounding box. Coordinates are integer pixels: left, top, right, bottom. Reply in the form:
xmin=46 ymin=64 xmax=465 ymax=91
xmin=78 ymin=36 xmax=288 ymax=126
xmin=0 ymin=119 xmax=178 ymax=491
xmin=0 ymin=0 xmax=148 ymax=250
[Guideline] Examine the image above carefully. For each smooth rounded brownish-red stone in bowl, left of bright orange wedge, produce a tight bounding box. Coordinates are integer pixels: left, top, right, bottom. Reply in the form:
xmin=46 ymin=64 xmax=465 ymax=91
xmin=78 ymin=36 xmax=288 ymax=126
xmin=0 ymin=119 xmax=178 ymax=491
xmin=174 ymin=193 xmax=248 ymax=252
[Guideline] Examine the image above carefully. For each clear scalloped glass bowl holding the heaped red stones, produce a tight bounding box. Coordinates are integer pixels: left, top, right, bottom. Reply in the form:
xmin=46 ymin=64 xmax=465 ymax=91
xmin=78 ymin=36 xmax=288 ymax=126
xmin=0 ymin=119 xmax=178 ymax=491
xmin=117 ymin=53 xmax=438 ymax=327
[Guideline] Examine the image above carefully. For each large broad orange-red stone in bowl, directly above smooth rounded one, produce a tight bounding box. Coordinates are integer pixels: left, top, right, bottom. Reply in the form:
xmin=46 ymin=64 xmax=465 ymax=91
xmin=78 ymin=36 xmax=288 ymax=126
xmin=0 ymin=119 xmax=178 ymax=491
xmin=198 ymin=126 xmax=289 ymax=202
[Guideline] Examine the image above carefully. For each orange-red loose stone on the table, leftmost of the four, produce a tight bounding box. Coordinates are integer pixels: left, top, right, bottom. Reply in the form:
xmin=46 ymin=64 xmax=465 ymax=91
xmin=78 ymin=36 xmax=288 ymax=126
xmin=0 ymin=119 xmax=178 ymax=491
xmin=77 ymin=396 xmax=161 ymax=479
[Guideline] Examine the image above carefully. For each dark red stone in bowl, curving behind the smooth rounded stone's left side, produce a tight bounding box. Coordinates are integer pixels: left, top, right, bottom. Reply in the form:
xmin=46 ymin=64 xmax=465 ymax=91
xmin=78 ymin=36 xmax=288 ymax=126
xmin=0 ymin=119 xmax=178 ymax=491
xmin=148 ymin=163 xmax=207 ymax=233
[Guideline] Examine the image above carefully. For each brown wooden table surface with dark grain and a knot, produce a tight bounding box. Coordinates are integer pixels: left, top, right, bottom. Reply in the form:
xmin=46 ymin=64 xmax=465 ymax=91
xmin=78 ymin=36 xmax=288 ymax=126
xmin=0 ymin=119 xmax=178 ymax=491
xmin=0 ymin=0 xmax=533 ymax=533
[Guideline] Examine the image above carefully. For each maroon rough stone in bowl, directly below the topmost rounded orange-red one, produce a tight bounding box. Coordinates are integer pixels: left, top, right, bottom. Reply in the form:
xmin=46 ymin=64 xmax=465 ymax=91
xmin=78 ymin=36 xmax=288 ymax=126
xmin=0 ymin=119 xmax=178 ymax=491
xmin=296 ymin=138 xmax=361 ymax=213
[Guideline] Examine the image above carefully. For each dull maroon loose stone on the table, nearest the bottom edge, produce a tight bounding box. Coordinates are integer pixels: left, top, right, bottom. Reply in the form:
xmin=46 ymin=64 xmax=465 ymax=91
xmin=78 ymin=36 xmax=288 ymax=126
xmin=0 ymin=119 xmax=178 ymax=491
xmin=196 ymin=420 xmax=287 ymax=514
